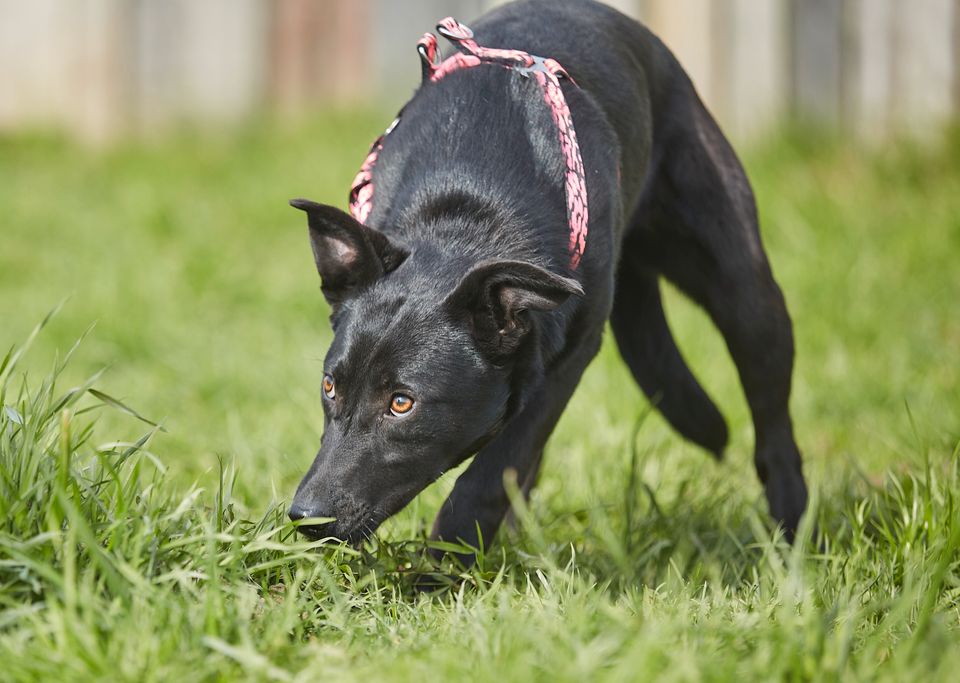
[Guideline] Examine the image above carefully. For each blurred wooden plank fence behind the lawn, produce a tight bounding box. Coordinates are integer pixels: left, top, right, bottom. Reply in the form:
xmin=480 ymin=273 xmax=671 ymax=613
xmin=0 ymin=0 xmax=960 ymax=141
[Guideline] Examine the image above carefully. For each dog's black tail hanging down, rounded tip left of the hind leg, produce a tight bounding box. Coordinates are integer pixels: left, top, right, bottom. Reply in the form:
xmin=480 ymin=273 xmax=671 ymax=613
xmin=610 ymin=259 xmax=727 ymax=458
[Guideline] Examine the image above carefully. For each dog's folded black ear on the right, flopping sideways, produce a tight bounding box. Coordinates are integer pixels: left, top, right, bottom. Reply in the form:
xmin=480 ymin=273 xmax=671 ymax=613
xmin=445 ymin=260 xmax=583 ymax=357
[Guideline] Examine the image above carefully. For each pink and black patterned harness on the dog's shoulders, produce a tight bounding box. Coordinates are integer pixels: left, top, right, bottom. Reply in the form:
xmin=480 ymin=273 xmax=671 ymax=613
xmin=350 ymin=17 xmax=588 ymax=269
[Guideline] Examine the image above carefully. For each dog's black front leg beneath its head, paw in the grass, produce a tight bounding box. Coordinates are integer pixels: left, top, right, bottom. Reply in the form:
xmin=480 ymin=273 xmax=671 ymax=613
xmin=433 ymin=333 xmax=600 ymax=565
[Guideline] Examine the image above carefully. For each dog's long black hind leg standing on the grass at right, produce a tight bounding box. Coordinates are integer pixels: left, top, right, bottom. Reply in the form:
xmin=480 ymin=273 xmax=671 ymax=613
xmin=618 ymin=99 xmax=807 ymax=538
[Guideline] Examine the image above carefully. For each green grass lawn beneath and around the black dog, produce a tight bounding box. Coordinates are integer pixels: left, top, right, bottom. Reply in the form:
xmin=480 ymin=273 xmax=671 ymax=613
xmin=0 ymin=115 xmax=960 ymax=681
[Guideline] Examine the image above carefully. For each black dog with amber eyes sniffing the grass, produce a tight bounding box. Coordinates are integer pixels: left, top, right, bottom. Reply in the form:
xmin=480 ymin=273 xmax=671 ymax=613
xmin=290 ymin=0 xmax=807 ymax=546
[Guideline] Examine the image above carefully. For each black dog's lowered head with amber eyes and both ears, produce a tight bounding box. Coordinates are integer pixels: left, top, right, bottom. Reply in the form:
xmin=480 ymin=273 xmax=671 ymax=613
xmin=290 ymin=199 xmax=582 ymax=541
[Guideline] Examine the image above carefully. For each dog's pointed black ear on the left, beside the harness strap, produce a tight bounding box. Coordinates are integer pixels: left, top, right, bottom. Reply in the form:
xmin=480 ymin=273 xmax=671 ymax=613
xmin=290 ymin=199 xmax=408 ymax=306
